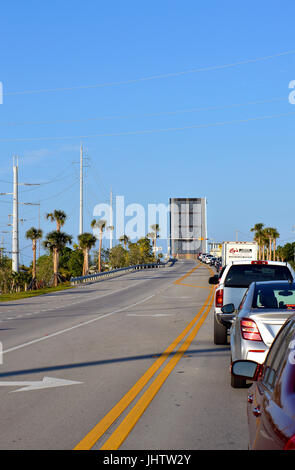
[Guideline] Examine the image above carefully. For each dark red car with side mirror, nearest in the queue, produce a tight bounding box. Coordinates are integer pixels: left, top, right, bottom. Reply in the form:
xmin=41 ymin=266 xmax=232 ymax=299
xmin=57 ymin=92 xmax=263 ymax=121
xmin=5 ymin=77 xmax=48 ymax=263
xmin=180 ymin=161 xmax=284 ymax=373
xmin=231 ymin=315 xmax=295 ymax=450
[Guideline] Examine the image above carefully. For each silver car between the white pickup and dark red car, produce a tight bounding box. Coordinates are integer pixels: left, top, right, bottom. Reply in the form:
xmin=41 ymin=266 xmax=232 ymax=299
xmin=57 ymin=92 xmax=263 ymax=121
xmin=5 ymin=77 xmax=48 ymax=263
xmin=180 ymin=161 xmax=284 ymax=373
xmin=222 ymin=281 xmax=295 ymax=388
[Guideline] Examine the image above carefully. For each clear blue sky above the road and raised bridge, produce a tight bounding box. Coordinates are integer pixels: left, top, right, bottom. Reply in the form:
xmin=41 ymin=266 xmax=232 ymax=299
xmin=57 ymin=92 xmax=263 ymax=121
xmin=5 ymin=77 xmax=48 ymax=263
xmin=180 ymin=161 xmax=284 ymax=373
xmin=0 ymin=0 xmax=295 ymax=264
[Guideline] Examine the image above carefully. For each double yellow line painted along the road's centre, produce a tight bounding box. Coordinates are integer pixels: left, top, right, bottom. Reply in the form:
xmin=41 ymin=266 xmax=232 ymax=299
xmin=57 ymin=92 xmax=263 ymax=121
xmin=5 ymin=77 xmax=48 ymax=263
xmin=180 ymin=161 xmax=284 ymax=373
xmin=74 ymin=262 xmax=214 ymax=450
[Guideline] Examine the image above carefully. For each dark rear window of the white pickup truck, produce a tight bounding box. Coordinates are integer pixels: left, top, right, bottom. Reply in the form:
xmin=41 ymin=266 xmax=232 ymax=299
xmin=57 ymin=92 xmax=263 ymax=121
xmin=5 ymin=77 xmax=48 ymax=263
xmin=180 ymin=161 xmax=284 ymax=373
xmin=224 ymin=264 xmax=293 ymax=287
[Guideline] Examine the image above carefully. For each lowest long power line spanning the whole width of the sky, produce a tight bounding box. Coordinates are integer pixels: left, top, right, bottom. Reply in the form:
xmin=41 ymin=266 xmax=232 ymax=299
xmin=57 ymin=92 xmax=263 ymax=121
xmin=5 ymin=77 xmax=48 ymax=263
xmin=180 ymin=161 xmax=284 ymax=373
xmin=0 ymin=111 xmax=295 ymax=143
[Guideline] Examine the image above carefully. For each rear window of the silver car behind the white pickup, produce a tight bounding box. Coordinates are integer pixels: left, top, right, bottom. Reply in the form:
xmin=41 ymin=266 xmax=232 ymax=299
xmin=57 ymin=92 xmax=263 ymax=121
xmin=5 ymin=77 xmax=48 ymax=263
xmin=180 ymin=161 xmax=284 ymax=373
xmin=252 ymin=283 xmax=295 ymax=310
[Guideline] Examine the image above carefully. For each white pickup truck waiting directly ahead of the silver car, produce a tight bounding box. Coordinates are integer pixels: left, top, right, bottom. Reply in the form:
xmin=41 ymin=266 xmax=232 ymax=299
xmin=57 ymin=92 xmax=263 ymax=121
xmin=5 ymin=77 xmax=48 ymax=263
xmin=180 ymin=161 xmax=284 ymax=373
xmin=209 ymin=261 xmax=295 ymax=344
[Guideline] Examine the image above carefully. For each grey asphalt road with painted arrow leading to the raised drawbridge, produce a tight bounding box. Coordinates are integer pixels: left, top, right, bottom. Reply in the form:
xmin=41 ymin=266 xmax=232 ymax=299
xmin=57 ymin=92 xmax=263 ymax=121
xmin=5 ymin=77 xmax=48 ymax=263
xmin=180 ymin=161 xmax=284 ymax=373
xmin=0 ymin=261 xmax=247 ymax=450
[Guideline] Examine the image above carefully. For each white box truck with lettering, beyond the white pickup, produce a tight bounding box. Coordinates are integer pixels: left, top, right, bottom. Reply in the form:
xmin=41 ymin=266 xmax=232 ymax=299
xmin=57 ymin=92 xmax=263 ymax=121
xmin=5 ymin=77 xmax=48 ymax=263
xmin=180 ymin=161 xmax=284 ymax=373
xmin=221 ymin=242 xmax=258 ymax=266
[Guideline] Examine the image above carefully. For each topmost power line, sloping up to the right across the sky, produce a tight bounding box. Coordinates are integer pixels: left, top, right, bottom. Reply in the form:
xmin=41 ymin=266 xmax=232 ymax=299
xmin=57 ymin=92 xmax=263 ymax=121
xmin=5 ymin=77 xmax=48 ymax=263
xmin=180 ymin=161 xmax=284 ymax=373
xmin=4 ymin=50 xmax=295 ymax=95
